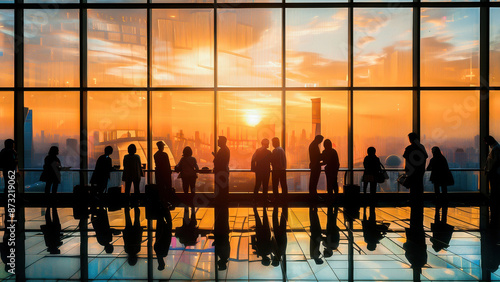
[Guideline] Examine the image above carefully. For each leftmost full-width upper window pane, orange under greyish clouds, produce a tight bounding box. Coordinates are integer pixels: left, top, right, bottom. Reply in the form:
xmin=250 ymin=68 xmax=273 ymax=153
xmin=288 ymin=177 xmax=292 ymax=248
xmin=24 ymin=9 xmax=80 ymax=87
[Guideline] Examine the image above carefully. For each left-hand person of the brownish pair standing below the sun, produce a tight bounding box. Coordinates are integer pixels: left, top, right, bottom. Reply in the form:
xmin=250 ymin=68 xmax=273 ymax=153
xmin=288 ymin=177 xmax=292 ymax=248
xmin=250 ymin=139 xmax=271 ymax=196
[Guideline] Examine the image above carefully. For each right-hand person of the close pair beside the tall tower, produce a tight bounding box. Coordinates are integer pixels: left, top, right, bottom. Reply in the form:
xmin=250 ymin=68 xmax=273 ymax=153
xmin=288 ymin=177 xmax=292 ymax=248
xmin=321 ymin=139 xmax=340 ymax=197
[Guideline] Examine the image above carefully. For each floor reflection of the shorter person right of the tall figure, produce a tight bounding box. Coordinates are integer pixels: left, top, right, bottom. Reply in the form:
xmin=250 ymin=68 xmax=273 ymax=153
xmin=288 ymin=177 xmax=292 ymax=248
xmin=431 ymin=203 xmax=454 ymax=252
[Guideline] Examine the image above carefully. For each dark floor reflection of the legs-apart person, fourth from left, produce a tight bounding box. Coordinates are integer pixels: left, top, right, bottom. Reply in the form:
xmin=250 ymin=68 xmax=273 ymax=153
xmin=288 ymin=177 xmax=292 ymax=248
xmin=123 ymin=207 xmax=143 ymax=265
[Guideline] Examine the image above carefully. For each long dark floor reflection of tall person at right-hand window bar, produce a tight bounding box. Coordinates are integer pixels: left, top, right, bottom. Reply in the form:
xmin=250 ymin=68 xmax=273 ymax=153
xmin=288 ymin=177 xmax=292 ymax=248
xmin=403 ymin=201 xmax=427 ymax=281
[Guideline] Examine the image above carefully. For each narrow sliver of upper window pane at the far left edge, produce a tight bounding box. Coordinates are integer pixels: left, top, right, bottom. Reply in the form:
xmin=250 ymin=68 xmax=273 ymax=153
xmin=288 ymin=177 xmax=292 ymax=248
xmin=0 ymin=10 xmax=14 ymax=87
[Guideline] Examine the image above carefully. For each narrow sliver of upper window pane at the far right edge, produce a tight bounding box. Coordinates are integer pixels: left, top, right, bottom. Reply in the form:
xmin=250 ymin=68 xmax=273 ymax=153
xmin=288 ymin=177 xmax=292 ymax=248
xmin=490 ymin=8 xmax=500 ymax=86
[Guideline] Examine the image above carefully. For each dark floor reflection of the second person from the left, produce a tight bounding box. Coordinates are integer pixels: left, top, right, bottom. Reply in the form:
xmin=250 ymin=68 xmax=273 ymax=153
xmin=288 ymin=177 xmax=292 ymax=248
xmin=40 ymin=206 xmax=63 ymax=255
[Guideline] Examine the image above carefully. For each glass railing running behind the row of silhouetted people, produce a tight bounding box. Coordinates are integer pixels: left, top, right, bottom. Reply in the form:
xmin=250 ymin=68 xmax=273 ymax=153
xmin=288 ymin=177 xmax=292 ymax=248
xmin=0 ymin=168 xmax=481 ymax=193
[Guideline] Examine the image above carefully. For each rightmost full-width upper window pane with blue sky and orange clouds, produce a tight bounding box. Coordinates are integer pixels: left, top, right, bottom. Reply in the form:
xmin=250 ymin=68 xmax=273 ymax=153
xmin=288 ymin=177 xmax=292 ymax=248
xmin=420 ymin=8 xmax=479 ymax=86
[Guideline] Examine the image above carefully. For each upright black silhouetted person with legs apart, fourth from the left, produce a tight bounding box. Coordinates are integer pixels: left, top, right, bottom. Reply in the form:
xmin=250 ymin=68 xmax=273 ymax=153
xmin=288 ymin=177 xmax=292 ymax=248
xmin=122 ymin=144 xmax=144 ymax=197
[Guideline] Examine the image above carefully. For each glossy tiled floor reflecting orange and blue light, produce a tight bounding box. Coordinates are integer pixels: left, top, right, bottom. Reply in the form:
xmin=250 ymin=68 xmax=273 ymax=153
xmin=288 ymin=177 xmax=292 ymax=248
xmin=0 ymin=206 xmax=500 ymax=281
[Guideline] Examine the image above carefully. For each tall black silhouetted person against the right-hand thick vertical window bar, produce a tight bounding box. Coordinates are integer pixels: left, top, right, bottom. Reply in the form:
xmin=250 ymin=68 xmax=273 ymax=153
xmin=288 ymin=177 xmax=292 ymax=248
xmin=403 ymin=132 xmax=428 ymax=200
